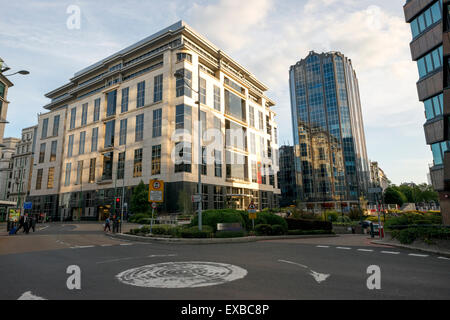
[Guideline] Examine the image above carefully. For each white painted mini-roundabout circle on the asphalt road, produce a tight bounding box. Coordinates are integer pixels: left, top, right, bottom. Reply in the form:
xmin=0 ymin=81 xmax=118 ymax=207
xmin=116 ymin=261 xmax=247 ymax=288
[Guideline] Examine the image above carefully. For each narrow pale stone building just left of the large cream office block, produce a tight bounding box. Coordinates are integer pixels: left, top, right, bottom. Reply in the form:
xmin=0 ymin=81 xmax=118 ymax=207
xmin=8 ymin=126 xmax=37 ymax=208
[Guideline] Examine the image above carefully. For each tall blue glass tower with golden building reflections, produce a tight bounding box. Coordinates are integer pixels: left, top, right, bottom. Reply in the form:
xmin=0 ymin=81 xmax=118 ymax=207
xmin=289 ymin=52 xmax=370 ymax=211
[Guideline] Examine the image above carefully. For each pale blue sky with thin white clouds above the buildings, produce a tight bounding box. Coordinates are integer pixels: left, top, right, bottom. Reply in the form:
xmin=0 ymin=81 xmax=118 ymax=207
xmin=0 ymin=0 xmax=432 ymax=184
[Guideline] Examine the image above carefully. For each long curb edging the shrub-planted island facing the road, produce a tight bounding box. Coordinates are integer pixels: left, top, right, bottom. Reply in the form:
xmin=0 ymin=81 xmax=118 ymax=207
xmin=105 ymin=233 xmax=338 ymax=244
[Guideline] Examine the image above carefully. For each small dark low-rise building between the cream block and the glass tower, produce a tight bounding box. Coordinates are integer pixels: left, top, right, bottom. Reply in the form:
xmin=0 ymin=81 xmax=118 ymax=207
xmin=278 ymin=146 xmax=297 ymax=207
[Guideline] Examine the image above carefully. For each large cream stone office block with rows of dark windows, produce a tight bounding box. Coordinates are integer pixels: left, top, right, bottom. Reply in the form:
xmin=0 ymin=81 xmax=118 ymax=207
xmin=29 ymin=21 xmax=280 ymax=220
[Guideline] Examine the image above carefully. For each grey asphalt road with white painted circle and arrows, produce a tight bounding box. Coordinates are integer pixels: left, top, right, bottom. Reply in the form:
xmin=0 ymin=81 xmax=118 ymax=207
xmin=0 ymin=223 xmax=450 ymax=300
